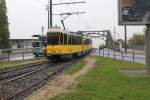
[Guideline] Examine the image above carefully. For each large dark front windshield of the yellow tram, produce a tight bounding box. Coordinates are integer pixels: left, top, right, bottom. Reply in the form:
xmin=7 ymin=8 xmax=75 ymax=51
xmin=47 ymin=34 xmax=60 ymax=45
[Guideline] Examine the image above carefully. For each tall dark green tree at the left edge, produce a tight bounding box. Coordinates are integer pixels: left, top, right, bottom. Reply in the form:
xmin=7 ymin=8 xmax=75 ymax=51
xmin=0 ymin=0 xmax=10 ymax=49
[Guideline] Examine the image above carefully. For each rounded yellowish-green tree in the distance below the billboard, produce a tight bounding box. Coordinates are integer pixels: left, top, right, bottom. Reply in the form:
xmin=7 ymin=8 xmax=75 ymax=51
xmin=128 ymin=33 xmax=145 ymax=45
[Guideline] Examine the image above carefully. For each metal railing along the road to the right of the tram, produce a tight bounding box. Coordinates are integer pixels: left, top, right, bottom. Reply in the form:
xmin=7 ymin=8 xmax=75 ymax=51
xmin=92 ymin=48 xmax=145 ymax=64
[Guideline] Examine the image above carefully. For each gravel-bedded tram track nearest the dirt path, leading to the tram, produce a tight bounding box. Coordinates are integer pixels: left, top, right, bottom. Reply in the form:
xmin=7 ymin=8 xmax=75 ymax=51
xmin=0 ymin=58 xmax=82 ymax=100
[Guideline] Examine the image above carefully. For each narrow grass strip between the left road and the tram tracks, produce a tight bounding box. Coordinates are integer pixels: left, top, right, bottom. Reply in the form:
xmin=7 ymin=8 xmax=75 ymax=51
xmin=0 ymin=57 xmax=46 ymax=70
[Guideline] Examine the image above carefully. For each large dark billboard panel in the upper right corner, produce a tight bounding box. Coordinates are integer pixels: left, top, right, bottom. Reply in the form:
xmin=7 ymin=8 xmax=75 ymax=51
xmin=118 ymin=0 xmax=150 ymax=25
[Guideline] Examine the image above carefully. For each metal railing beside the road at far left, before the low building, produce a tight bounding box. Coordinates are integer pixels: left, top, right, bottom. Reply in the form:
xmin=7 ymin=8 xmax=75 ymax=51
xmin=0 ymin=48 xmax=33 ymax=61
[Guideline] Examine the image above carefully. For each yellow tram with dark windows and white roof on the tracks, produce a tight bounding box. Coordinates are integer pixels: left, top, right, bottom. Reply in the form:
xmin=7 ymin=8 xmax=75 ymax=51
xmin=46 ymin=28 xmax=92 ymax=58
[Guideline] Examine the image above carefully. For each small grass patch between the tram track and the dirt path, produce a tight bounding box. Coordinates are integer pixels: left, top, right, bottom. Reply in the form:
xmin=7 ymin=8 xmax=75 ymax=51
xmin=66 ymin=60 xmax=86 ymax=75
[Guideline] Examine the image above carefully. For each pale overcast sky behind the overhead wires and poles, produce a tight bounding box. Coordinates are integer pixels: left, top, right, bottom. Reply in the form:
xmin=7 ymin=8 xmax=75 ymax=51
xmin=6 ymin=0 xmax=144 ymax=38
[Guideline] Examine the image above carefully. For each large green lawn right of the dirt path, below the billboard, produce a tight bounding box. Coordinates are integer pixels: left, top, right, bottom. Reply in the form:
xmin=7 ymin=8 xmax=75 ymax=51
xmin=49 ymin=57 xmax=150 ymax=100
